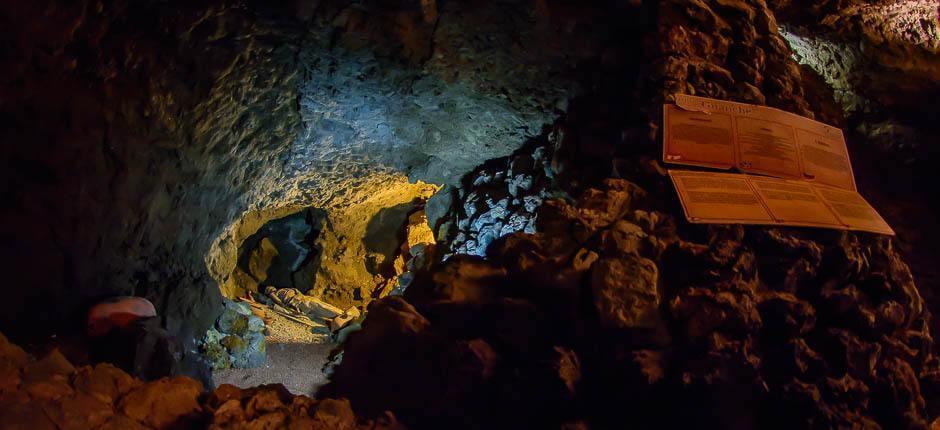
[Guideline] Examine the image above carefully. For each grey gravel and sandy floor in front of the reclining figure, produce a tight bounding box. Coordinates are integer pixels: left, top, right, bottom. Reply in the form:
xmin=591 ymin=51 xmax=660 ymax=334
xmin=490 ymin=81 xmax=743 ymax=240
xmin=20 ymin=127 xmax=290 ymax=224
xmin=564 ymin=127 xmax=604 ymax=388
xmin=212 ymin=306 xmax=335 ymax=396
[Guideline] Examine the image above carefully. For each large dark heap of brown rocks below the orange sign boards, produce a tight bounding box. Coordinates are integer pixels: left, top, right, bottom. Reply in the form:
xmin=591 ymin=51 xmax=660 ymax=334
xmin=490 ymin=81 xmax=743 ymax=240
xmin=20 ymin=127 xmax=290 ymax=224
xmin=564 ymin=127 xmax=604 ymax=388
xmin=321 ymin=180 xmax=940 ymax=429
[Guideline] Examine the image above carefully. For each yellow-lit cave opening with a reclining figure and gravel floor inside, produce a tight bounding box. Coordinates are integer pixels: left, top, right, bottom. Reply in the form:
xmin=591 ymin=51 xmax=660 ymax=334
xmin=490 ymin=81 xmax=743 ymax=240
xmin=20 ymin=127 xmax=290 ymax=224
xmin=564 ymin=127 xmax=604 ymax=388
xmin=206 ymin=183 xmax=439 ymax=394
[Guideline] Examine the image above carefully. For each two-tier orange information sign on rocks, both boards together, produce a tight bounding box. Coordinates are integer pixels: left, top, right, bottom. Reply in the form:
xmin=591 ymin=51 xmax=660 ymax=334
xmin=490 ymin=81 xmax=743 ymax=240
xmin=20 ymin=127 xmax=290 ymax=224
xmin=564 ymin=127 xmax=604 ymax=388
xmin=663 ymin=95 xmax=894 ymax=235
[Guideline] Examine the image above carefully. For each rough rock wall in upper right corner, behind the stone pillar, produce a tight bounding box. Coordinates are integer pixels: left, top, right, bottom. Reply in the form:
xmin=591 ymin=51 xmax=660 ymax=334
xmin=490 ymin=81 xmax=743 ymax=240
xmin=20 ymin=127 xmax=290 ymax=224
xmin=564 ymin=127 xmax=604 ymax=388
xmin=770 ymin=0 xmax=940 ymax=342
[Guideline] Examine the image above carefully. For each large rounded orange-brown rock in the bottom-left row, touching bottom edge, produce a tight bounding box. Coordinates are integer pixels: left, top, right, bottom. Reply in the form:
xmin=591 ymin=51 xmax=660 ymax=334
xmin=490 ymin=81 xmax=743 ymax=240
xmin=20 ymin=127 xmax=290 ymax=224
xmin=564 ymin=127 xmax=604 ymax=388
xmin=118 ymin=376 xmax=202 ymax=428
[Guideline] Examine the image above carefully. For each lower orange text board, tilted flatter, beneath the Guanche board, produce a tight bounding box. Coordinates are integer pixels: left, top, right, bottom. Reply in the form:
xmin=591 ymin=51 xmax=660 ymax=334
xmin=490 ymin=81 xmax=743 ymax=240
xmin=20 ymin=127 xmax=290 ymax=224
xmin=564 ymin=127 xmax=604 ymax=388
xmin=669 ymin=170 xmax=894 ymax=236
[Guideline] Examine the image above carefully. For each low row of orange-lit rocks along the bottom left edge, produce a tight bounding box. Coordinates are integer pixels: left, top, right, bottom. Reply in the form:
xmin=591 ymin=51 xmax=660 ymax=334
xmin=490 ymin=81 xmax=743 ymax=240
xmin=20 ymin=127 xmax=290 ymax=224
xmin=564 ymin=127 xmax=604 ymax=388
xmin=0 ymin=334 xmax=396 ymax=430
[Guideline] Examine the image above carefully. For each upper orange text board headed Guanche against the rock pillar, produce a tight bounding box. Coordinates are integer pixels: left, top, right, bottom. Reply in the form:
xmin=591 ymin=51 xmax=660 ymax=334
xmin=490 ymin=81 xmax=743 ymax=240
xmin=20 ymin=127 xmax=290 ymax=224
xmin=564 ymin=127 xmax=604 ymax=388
xmin=663 ymin=94 xmax=856 ymax=191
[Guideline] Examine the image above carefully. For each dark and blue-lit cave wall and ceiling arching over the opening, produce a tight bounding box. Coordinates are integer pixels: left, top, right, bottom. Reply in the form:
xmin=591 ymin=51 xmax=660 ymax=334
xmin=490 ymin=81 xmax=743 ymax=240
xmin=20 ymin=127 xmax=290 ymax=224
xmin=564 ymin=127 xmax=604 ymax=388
xmin=0 ymin=0 xmax=609 ymax=358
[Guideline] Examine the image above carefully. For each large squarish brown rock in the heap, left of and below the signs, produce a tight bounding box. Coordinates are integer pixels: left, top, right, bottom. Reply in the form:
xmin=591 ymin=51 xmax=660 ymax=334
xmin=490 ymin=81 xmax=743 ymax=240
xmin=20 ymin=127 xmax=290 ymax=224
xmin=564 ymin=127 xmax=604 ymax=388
xmin=591 ymin=256 xmax=659 ymax=328
